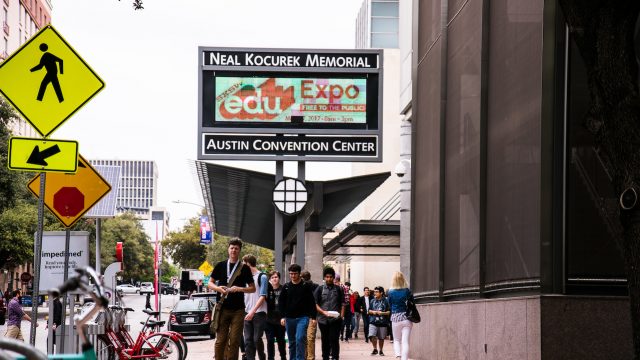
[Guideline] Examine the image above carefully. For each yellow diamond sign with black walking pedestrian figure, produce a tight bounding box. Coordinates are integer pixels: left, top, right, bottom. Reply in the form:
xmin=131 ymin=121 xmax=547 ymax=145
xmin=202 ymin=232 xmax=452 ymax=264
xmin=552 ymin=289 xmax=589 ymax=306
xmin=0 ymin=26 xmax=104 ymax=137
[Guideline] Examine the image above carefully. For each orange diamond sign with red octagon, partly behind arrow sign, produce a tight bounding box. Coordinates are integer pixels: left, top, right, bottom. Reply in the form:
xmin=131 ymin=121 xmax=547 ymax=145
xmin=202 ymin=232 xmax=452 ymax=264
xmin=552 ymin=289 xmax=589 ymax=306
xmin=27 ymin=155 xmax=111 ymax=227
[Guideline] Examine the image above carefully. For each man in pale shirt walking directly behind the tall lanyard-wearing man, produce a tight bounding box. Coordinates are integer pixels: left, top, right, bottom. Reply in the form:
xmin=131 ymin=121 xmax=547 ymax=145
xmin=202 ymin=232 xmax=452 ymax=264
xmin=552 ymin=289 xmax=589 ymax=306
xmin=242 ymin=254 xmax=269 ymax=360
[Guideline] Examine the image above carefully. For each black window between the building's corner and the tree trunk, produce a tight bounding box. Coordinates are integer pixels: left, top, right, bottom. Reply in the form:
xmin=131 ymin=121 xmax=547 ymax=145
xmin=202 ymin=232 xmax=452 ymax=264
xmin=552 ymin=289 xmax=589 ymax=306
xmin=566 ymin=40 xmax=626 ymax=279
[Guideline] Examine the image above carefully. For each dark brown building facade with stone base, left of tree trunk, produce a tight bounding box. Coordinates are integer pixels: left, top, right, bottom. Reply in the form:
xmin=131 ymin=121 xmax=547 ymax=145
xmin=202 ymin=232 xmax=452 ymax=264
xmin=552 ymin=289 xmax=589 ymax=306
xmin=409 ymin=0 xmax=633 ymax=359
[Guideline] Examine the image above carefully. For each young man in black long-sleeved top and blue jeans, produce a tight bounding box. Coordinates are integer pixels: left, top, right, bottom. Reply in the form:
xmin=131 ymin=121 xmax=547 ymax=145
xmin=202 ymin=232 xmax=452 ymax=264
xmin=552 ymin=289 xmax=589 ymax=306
xmin=278 ymin=264 xmax=316 ymax=360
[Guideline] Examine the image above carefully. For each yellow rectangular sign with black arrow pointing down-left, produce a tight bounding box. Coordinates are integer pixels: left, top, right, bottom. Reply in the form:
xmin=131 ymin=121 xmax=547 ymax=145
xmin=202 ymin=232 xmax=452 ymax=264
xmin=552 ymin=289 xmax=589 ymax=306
xmin=8 ymin=137 xmax=78 ymax=173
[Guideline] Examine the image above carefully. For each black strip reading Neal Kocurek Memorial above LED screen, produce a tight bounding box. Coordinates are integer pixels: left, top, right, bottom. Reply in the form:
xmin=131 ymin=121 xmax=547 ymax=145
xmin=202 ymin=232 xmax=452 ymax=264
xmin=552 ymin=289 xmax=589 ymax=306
xmin=202 ymin=50 xmax=378 ymax=69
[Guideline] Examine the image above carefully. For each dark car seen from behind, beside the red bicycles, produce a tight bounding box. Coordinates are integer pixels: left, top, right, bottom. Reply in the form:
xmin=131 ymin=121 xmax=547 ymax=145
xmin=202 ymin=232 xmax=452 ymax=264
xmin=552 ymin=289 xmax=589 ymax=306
xmin=167 ymin=298 xmax=213 ymax=338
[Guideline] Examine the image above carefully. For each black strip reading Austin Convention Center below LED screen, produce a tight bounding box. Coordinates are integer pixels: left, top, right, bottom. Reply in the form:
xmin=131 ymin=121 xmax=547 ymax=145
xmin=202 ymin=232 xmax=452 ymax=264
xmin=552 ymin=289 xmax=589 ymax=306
xmin=202 ymin=134 xmax=378 ymax=161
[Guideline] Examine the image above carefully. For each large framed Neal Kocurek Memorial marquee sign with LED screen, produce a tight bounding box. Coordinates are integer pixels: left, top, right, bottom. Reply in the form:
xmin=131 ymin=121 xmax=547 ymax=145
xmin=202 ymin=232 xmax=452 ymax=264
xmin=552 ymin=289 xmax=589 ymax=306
xmin=198 ymin=47 xmax=382 ymax=161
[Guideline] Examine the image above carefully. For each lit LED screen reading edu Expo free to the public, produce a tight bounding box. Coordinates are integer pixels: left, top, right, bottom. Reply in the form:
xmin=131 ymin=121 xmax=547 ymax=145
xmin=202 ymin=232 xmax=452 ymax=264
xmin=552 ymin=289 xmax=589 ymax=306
xmin=213 ymin=76 xmax=367 ymax=125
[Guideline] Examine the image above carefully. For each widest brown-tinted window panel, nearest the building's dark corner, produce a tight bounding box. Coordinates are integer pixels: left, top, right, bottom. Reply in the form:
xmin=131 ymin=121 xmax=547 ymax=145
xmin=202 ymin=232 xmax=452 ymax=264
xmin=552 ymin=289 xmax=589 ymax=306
xmin=486 ymin=0 xmax=543 ymax=283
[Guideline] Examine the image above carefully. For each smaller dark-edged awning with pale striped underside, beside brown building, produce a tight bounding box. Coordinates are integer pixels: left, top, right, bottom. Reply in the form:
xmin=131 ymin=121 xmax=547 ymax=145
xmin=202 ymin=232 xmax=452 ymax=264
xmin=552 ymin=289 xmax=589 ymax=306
xmin=324 ymin=220 xmax=400 ymax=262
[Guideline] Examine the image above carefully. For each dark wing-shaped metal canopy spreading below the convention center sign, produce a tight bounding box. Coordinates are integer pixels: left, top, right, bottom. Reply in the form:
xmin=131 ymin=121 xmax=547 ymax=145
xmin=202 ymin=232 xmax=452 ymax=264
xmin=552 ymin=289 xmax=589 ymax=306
xmin=195 ymin=161 xmax=391 ymax=252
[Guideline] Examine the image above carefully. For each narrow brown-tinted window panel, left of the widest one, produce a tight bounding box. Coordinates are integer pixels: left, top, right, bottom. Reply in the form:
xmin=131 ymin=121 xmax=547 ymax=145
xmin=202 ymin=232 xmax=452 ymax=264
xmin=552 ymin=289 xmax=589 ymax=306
xmin=444 ymin=1 xmax=482 ymax=289
